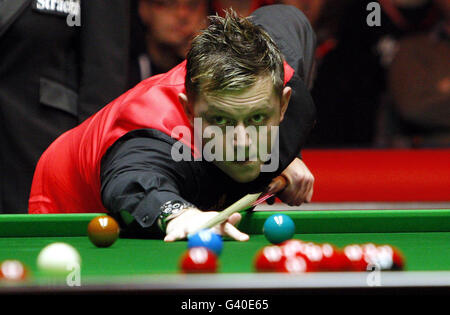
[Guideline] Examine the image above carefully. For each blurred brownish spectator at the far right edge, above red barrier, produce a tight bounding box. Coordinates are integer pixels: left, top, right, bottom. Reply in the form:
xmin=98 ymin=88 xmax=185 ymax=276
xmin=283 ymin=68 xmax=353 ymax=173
xmin=378 ymin=0 xmax=450 ymax=147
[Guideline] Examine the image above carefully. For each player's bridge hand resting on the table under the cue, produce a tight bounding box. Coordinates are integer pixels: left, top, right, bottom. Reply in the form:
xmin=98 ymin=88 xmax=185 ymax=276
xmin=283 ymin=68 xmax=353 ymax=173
xmin=164 ymin=208 xmax=250 ymax=242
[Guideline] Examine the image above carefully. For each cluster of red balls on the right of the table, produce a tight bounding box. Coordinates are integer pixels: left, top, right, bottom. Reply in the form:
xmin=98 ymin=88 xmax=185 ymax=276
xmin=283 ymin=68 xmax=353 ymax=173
xmin=254 ymin=239 xmax=404 ymax=273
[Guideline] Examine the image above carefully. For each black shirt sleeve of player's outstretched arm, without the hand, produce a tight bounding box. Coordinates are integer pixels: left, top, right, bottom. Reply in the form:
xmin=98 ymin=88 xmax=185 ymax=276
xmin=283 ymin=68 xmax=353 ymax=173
xmin=101 ymin=130 xmax=196 ymax=228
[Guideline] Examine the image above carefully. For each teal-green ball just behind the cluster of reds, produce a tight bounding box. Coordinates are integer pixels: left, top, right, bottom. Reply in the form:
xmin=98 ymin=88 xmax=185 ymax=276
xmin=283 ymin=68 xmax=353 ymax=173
xmin=263 ymin=214 xmax=295 ymax=244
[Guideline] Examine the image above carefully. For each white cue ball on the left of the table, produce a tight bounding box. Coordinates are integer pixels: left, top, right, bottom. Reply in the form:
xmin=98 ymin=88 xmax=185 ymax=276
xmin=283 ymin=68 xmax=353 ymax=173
xmin=37 ymin=243 xmax=81 ymax=275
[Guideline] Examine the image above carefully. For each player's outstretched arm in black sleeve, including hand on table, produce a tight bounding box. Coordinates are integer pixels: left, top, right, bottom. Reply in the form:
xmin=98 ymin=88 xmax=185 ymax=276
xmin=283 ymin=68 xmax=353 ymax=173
xmin=101 ymin=130 xmax=248 ymax=241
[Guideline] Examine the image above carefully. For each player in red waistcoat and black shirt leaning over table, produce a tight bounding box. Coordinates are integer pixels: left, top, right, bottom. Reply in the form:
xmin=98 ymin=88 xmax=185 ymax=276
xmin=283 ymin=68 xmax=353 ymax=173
xmin=29 ymin=5 xmax=315 ymax=241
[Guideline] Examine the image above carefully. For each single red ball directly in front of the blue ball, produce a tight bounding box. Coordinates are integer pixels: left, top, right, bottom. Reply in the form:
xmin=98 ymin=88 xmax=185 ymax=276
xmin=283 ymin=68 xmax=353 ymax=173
xmin=180 ymin=247 xmax=218 ymax=273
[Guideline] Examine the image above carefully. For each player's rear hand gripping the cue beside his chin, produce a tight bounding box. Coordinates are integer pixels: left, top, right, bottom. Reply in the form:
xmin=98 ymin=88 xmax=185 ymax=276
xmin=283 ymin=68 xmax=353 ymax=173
xmin=271 ymin=158 xmax=314 ymax=206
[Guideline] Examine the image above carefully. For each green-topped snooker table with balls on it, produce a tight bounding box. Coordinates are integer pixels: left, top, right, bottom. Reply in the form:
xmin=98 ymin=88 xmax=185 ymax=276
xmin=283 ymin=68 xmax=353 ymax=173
xmin=0 ymin=204 xmax=450 ymax=294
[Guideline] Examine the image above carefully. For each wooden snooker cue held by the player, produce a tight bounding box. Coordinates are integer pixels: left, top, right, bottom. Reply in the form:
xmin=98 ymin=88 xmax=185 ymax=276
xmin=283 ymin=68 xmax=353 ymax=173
xmin=190 ymin=175 xmax=288 ymax=235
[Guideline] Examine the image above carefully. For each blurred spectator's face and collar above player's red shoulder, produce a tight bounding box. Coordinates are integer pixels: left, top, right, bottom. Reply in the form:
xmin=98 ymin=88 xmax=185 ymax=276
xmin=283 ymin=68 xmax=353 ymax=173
xmin=131 ymin=0 xmax=209 ymax=85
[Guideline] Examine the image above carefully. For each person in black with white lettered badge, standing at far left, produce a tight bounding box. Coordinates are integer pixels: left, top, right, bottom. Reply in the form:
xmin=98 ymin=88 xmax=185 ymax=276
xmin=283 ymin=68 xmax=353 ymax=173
xmin=0 ymin=0 xmax=129 ymax=213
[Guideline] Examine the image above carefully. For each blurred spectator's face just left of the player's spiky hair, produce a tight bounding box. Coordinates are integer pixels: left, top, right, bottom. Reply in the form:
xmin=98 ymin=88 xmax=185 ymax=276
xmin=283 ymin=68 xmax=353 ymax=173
xmin=139 ymin=0 xmax=208 ymax=54
